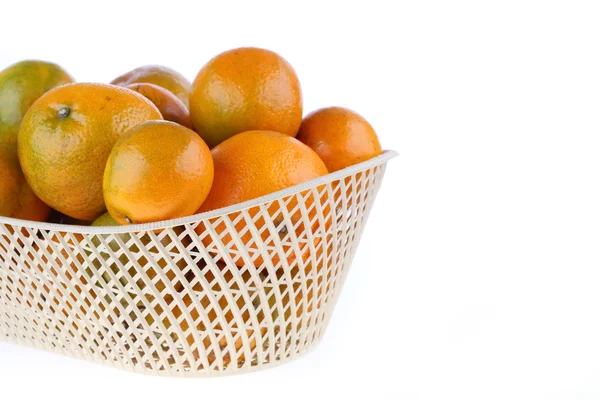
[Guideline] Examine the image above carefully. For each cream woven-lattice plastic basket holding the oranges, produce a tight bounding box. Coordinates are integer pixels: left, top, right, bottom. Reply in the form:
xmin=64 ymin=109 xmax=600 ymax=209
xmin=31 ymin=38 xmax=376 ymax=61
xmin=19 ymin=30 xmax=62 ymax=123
xmin=0 ymin=151 xmax=396 ymax=377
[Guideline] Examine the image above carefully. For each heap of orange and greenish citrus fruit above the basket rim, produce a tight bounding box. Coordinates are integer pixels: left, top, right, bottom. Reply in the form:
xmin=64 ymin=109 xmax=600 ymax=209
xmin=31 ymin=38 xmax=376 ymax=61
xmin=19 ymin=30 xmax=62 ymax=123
xmin=0 ymin=48 xmax=382 ymax=233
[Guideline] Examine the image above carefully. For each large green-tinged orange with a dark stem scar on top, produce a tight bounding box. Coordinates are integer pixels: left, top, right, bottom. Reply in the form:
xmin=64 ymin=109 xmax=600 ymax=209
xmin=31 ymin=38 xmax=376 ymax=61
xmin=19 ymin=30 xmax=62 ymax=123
xmin=18 ymin=83 xmax=162 ymax=221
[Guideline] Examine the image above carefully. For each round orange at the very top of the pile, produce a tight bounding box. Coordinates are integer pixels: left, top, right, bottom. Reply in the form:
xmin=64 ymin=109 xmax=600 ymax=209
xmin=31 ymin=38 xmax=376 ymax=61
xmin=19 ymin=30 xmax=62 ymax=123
xmin=190 ymin=48 xmax=302 ymax=147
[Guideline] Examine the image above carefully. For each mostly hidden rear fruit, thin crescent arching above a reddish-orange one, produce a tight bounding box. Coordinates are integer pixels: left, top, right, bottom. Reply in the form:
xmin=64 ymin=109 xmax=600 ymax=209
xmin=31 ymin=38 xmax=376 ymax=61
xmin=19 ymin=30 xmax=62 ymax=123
xmin=111 ymin=65 xmax=192 ymax=107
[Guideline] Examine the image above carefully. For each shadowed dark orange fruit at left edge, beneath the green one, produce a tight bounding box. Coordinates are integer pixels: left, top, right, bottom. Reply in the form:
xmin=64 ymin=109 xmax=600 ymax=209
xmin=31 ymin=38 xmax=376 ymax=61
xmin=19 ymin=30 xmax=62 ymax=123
xmin=0 ymin=143 xmax=51 ymax=221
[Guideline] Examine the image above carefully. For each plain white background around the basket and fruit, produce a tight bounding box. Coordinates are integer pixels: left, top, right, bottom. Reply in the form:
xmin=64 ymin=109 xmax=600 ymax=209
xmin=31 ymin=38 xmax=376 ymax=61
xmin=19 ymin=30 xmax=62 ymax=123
xmin=0 ymin=0 xmax=600 ymax=400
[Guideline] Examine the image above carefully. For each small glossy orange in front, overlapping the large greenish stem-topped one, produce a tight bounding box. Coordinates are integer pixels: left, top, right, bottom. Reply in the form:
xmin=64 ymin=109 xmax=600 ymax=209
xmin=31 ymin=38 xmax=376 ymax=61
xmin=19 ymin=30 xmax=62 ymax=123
xmin=104 ymin=121 xmax=214 ymax=225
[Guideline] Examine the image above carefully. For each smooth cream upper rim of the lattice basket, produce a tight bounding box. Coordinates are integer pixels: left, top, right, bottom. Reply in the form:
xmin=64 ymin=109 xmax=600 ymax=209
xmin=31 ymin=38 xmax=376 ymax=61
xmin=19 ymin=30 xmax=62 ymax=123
xmin=0 ymin=150 xmax=398 ymax=235
